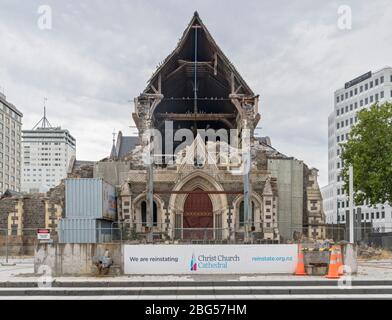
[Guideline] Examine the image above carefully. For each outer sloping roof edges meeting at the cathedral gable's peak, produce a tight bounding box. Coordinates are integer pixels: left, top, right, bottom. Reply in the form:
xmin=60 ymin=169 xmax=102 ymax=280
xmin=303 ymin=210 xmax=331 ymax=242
xmin=145 ymin=12 xmax=254 ymax=95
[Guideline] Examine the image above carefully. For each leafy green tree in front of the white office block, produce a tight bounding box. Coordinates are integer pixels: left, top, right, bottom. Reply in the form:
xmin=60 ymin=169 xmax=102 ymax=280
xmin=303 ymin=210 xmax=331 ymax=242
xmin=340 ymin=102 xmax=392 ymax=205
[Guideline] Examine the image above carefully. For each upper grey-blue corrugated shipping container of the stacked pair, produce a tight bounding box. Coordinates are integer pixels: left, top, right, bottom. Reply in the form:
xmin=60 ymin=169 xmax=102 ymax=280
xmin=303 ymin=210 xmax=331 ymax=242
xmin=65 ymin=178 xmax=117 ymax=220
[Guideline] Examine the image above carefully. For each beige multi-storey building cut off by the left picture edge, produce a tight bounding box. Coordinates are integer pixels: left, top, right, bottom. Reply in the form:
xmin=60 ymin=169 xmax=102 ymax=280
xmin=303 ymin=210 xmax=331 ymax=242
xmin=0 ymin=93 xmax=23 ymax=195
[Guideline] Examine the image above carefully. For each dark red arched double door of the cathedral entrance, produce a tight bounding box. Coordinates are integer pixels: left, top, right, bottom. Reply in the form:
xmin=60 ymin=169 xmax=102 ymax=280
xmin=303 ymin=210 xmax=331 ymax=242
xmin=183 ymin=188 xmax=214 ymax=240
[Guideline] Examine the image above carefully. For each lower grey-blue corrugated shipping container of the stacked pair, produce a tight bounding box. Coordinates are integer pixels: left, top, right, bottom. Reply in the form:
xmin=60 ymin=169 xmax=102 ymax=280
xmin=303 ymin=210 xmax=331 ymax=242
xmin=58 ymin=218 xmax=112 ymax=243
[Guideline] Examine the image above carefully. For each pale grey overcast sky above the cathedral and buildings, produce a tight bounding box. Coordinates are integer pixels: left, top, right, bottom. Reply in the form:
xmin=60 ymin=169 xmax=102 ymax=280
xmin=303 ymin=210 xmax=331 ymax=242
xmin=0 ymin=0 xmax=392 ymax=186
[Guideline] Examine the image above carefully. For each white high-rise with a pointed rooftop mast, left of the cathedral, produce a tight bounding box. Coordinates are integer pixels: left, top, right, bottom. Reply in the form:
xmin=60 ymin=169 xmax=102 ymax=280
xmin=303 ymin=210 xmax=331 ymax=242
xmin=22 ymin=112 xmax=76 ymax=193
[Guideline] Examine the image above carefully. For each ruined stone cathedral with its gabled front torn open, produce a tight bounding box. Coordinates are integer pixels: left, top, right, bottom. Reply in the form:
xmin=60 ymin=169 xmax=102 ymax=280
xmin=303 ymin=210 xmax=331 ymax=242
xmin=0 ymin=13 xmax=326 ymax=243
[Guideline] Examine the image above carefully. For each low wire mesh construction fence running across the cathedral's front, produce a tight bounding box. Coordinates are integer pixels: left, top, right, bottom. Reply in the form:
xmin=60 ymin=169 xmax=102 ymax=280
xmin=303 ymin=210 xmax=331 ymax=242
xmin=0 ymin=222 xmax=392 ymax=261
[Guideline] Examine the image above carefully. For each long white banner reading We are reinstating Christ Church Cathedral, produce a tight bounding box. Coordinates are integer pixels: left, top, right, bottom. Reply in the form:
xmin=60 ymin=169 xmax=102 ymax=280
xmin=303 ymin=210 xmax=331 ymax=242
xmin=123 ymin=244 xmax=297 ymax=274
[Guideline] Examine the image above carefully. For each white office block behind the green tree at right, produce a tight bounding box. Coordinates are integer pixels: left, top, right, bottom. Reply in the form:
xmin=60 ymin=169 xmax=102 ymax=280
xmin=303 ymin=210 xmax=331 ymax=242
xmin=322 ymin=67 xmax=392 ymax=232
